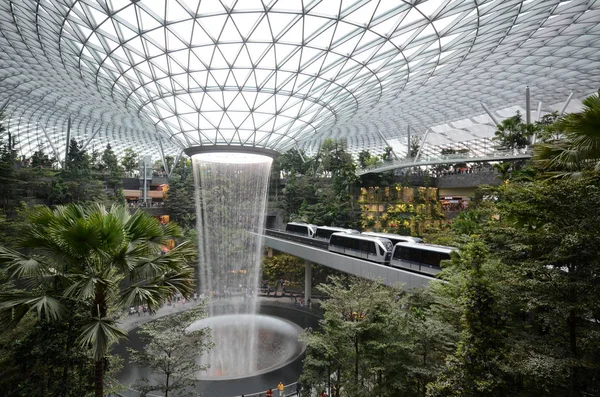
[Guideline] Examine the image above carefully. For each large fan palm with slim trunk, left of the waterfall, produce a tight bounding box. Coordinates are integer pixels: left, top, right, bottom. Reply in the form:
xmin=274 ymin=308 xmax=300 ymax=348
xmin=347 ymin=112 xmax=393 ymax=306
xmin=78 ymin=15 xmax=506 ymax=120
xmin=0 ymin=204 xmax=194 ymax=397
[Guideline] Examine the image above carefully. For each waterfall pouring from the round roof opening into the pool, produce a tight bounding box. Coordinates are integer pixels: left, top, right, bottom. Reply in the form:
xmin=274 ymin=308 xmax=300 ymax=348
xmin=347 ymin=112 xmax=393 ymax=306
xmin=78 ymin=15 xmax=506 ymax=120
xmin=192 ymin=148 xmax=272 ymax=377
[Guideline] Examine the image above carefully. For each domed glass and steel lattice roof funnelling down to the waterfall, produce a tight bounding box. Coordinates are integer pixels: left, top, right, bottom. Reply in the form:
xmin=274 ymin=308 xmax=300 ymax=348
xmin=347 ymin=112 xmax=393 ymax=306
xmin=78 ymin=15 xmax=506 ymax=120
xmin=0 ymin=0 xmax=600 ymax=159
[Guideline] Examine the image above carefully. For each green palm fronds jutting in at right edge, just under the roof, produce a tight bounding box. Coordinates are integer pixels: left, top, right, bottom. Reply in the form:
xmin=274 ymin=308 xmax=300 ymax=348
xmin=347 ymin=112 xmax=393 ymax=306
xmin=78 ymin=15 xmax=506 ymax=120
xmin=533 ymin=94 xmax=600 ymax=176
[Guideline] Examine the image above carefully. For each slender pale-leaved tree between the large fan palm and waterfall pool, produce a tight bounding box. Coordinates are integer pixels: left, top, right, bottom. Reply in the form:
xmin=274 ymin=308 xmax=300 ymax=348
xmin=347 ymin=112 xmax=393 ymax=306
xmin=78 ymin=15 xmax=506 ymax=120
xmin=127 ymin=306 xmax=212 ymax=397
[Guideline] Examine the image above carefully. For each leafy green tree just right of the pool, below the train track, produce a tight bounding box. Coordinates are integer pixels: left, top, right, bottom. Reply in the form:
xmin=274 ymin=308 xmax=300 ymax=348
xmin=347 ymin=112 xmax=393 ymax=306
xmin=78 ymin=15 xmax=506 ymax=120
xmin=300 ymin=277 xmax=410 ymax=397
